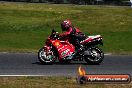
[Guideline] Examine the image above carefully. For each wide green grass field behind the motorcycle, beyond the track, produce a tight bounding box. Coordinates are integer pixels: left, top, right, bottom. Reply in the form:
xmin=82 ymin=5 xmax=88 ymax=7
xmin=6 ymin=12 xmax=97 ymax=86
xmin=0 ymin=2 xmax=132 ymax=54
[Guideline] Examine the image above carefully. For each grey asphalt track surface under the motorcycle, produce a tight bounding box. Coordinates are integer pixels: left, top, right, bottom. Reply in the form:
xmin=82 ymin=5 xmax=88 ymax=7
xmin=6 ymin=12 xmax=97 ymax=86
xmin=0 ymin=53 xmax=132 ymax=76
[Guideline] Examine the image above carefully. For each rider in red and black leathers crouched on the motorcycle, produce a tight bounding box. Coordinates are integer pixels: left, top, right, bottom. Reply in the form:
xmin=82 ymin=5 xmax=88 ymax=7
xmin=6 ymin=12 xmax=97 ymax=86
xmin=60 ymin=20 xmax=86 ymax=50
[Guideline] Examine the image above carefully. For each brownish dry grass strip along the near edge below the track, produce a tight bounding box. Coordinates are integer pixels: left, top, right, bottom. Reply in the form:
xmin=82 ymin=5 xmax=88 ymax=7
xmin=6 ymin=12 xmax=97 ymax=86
xmin=0 ymin=77 xmax=132 ymax=88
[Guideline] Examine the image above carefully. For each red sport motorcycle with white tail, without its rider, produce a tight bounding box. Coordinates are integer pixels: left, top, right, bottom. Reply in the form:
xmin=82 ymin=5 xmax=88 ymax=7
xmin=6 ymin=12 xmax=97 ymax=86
xmin=38 ymin=30 xmax=104 ymax=64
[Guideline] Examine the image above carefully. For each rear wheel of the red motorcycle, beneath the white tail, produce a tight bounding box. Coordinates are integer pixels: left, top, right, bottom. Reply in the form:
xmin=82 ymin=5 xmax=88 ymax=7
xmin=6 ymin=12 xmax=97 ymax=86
xmin=84 ymin=47 xmax=104 ymax=64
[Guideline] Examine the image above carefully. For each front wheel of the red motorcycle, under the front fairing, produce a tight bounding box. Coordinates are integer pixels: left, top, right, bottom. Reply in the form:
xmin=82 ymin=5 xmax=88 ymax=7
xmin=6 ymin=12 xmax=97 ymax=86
xmin=38 ymin=47 xmax=56 ymax=64
